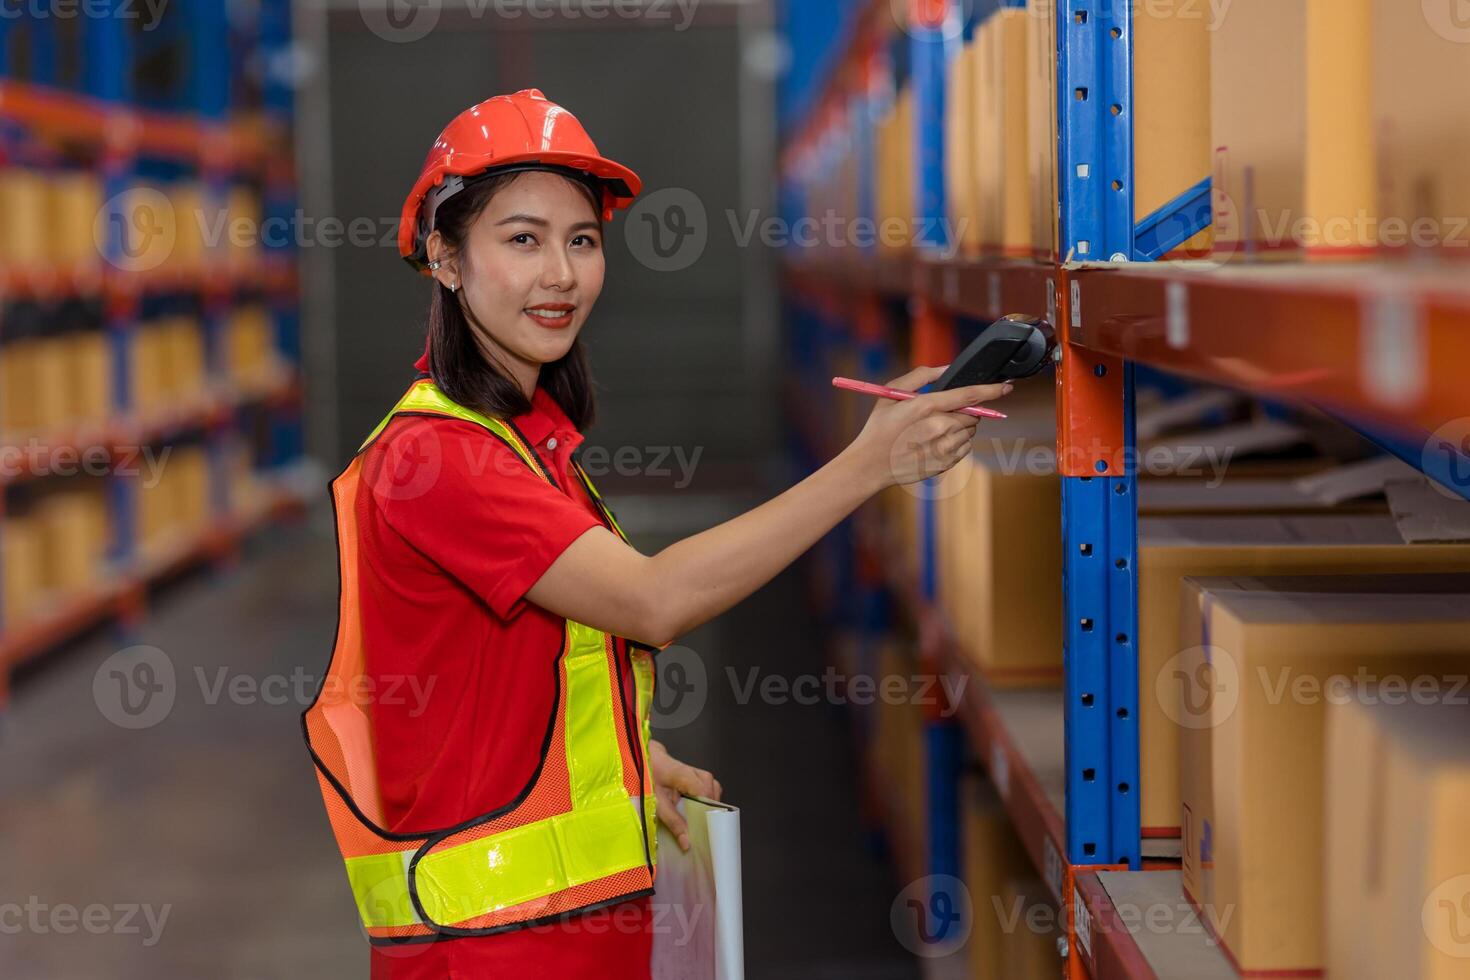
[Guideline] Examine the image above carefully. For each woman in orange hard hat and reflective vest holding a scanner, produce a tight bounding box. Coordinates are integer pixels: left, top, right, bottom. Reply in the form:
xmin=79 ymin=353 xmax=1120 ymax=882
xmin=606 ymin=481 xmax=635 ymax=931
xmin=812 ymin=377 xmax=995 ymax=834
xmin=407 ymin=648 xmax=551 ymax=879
xmin=303 ymin=90 xmax=1003 ymax=980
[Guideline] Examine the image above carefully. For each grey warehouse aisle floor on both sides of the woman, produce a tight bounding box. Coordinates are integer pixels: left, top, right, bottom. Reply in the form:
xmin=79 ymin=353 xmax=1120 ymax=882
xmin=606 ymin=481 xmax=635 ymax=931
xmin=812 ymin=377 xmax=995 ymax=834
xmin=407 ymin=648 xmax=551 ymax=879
xmin=0 ymin=511 xmax=917 ymax=980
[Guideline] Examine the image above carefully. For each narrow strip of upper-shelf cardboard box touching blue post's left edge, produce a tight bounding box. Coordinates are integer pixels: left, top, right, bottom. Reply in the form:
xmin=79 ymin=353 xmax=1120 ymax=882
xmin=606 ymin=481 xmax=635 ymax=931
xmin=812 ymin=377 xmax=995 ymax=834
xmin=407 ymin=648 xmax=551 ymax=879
xmin=1026 ymin=0 xmax=1057 ymax=260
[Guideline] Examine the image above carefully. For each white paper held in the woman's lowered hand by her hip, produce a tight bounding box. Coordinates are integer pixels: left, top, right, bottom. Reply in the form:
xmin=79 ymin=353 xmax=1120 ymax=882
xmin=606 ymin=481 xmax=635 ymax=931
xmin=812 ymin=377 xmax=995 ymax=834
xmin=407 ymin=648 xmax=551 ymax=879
xmin=653 ymin=796 xmax=745 ymax=980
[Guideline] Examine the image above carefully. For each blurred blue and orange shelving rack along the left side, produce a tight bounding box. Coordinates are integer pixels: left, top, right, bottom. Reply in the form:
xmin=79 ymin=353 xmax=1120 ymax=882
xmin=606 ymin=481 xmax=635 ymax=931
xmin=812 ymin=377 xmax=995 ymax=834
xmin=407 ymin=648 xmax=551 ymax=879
xmin=0 ymin=0 xmax=303 ymax=704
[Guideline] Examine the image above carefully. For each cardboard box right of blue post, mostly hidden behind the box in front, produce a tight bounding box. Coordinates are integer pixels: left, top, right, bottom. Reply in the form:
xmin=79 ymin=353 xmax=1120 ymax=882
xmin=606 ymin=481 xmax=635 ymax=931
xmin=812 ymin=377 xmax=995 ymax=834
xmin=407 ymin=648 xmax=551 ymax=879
xmin=1138 ymin=514 xmax=1470 ymax=836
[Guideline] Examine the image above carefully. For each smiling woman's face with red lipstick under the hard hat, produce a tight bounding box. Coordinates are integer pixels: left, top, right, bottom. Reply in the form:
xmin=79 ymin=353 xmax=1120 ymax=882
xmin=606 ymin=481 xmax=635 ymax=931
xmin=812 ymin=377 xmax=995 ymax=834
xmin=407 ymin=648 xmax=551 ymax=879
xmin=437 ymin=170 xmax=604 ymax=389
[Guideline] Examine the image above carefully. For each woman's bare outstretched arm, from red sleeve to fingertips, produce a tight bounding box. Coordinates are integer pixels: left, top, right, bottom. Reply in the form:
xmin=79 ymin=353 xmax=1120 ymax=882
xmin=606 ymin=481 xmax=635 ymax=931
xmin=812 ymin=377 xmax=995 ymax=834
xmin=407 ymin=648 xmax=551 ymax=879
xmin=526 ymin=367 xmax=1010 ymax=646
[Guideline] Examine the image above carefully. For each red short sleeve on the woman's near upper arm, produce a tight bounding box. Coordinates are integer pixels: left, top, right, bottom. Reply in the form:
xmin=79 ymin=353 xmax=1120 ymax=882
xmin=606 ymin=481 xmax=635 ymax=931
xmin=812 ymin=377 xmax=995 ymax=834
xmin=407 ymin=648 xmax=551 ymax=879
xmin=373 ymin=416 xmax=601 ymax=619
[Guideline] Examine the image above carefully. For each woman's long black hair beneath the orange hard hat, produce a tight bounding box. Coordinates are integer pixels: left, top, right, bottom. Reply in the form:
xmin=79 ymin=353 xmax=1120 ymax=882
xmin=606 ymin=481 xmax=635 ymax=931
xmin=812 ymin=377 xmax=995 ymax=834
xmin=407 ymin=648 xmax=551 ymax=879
xmin=429 ymin=170 xmax=603 ymax=430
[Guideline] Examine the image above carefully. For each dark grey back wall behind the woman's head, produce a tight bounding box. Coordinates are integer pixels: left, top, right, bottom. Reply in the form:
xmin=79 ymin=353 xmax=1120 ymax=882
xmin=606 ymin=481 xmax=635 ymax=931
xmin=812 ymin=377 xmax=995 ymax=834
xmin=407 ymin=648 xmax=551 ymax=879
xmin=304 ymin=10 xmax=775 ymax=492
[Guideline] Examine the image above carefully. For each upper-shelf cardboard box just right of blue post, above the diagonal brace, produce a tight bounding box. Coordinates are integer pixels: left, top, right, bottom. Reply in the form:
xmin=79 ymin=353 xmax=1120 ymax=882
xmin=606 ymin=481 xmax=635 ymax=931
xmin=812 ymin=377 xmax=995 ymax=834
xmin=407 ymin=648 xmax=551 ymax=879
xmin=1128 ymin=0 xmax=1211 ymax=259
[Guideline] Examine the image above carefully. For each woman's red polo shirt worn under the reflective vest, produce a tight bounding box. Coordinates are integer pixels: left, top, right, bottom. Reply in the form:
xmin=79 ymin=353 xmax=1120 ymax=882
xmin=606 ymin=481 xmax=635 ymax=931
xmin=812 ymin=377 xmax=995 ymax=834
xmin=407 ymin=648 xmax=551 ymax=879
xmin=356 ymin=348 xmax=651 ymax=980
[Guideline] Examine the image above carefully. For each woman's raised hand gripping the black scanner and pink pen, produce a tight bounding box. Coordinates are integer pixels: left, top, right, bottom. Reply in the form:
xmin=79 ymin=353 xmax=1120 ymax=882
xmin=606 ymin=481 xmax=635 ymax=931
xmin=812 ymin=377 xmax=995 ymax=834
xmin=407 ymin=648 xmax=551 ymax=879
xmin=847 ymin=364 xmax=1011 ymax=486
